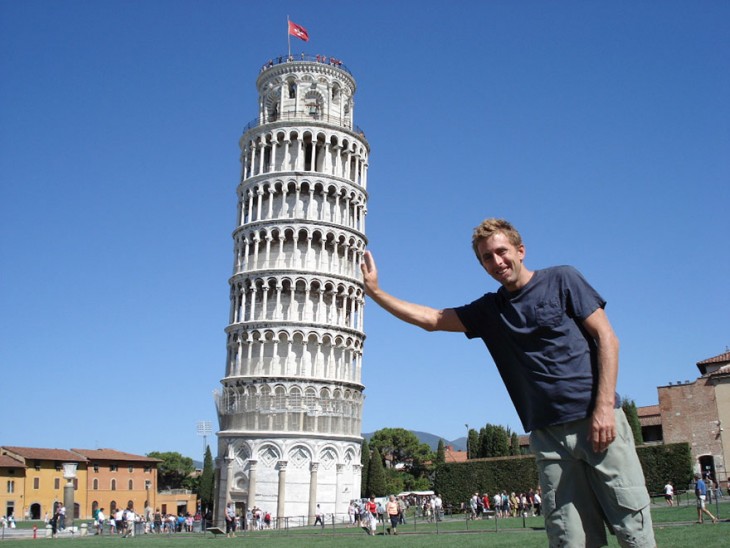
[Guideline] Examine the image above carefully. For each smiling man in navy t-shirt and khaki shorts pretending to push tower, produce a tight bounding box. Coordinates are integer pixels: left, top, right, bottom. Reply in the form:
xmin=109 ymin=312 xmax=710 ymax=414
xmin=362 ymin=219 xmax=655 ymax=547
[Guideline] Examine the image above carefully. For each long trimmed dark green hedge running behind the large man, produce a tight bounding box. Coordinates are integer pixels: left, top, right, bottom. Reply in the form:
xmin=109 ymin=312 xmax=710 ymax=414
xmin=433 ymin=443 xmax=692 ymax=504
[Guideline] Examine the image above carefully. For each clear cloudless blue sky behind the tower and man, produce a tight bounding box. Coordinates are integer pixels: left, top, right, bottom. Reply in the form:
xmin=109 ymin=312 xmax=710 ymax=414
xmin=0 ymin=0 xmax=730 ymax=458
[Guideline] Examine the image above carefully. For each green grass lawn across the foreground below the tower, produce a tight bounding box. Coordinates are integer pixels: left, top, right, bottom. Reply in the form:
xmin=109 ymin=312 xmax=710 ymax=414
xmin=0 ymin=502 xmax=730 ymax=548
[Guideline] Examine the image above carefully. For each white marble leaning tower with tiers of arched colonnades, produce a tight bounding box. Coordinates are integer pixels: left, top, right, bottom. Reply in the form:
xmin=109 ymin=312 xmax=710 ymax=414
xmin=215 ymin=55 xmax=369 ymax=525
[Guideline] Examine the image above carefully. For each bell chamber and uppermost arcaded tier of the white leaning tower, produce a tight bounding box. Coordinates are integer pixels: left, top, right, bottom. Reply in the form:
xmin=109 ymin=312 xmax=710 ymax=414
xmin=240 ymin=55 xmax=370 ymax=189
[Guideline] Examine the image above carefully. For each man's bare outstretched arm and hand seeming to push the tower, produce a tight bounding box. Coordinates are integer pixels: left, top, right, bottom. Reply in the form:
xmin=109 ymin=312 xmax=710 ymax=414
xmin=360 ymin=251 xmax=466 ymax=333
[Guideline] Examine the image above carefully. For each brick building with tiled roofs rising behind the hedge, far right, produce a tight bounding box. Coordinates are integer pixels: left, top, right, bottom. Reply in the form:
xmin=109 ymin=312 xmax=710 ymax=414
xmin=638 ymin=352 xmax=730 ymax=487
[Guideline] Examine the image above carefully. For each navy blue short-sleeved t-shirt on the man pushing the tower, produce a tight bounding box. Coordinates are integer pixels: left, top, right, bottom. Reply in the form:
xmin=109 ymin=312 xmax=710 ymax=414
xmin=455 ymin=266 xmax=606 ymax=432
